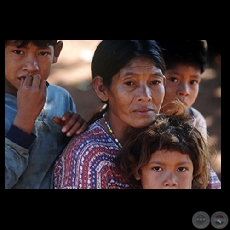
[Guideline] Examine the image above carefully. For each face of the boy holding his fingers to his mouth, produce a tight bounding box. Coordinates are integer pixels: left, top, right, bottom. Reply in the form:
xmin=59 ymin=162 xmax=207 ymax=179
xmin=5 ymin=40 xmax=62 ymax=93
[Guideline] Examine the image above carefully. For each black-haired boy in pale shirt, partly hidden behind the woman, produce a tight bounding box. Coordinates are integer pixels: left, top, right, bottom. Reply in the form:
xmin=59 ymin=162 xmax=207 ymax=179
xmin=156 ymin=39 xmax=221 ymax=189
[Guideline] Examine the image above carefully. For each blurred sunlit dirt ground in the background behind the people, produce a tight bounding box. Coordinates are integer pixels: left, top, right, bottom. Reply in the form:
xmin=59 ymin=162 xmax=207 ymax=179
xmin=48 ymin=40 xmax=221 ymax=180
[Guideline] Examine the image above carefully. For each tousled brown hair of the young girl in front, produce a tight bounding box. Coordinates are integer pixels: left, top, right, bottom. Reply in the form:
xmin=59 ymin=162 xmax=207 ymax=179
xmin=115 ymin=101 xmax=211 ymax=189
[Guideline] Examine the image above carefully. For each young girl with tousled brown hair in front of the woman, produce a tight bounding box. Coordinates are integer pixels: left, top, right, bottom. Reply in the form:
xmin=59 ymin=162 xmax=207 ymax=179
xmin=115 ymin=102 xmax=211 ymax=189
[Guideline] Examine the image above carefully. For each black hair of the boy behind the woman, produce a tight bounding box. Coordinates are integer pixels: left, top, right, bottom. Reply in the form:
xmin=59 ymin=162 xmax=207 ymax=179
xmin=156 ymin=39 xmax=208 ymax=73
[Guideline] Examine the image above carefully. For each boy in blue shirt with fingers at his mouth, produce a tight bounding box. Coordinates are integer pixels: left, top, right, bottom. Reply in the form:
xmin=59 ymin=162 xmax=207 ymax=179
xmin=5 ymin=40 xmax=87 ymax=189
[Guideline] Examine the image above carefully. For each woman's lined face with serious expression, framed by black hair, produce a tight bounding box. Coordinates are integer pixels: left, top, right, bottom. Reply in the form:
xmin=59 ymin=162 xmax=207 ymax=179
xmin=107 ymin=58 xmax=165 ymax=129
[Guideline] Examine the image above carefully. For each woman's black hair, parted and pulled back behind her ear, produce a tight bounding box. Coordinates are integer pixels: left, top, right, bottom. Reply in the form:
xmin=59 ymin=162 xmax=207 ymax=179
xmin=88 ymin=40 xmax=165 ymax=124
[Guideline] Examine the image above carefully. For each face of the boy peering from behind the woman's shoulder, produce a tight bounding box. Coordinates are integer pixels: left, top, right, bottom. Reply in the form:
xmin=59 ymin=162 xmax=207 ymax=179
xmin=163 ymin=64 xmax=201 ymax=108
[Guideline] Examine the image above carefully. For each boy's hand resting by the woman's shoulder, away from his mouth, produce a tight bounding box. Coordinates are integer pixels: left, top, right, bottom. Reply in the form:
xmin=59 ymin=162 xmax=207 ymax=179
xmin=53 ymin=111 xmax=88 ymax=137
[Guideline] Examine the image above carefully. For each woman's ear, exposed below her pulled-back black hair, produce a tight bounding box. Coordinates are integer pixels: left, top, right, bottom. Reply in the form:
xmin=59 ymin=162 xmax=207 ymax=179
xmin=92 ymin=76 xmax=109 ymax=102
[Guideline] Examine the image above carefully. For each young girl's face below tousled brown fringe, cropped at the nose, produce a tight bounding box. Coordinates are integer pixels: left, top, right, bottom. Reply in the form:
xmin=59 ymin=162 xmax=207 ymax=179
xmin=136 ymin=149 xmax=193 ymax=189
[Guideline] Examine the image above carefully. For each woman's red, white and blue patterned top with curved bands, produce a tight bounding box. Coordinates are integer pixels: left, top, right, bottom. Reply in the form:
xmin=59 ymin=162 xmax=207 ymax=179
xmin=54 ymin=120 xmax=129 ymax=189
